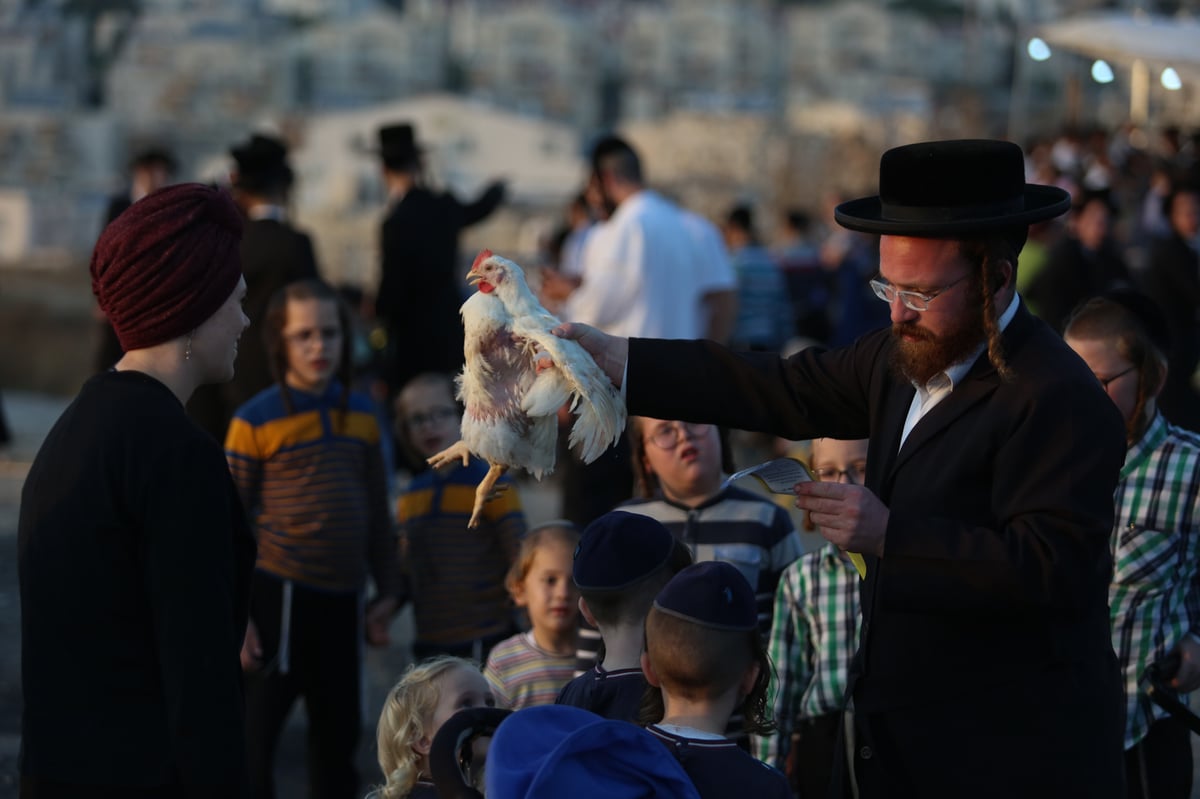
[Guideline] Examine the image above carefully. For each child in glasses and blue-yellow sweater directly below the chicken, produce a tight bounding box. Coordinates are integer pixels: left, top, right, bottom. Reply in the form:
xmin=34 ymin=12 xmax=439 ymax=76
xmin=395 ymin=372 xmax=526 ymax=662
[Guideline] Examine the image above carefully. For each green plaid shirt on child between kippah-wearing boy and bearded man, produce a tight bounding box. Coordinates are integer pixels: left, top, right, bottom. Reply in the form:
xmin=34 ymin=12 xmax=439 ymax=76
xmin=754 ymin=543 xmax=863 ymax=769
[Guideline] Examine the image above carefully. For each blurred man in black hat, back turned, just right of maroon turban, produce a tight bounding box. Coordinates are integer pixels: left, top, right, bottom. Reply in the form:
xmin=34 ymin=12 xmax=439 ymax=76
xmin=187 ymin=133 xmax=318 ymax=441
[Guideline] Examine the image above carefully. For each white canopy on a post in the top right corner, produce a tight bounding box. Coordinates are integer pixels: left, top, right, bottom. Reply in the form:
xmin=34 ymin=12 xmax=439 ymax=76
xmin=1021 ymin=12 xmax=1200 ymax=122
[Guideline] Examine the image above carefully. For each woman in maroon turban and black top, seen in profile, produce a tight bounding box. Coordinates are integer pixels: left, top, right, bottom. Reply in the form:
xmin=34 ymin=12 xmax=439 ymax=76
xmin=18 ymin=184 xmax=254 ymax=798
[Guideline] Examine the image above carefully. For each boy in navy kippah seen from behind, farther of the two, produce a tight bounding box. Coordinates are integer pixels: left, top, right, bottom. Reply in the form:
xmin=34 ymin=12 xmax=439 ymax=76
xmin=556 ymin=511 xmax=691 ymax=721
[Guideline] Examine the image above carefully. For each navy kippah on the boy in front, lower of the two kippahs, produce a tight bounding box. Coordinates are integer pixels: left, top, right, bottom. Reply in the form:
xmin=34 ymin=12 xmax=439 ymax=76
xmin=654 ymin=560 xmax=758 ymax=630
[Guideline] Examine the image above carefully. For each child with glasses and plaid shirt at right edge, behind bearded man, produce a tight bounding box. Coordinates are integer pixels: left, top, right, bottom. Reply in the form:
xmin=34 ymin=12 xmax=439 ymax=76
xmin=1063 ymin=290 xmax=1200 ymax=799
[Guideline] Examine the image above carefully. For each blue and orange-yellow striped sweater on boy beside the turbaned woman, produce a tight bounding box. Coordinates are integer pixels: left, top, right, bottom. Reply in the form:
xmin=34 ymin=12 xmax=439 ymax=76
xmin=226 ymin=383 xmax=400 ymax=595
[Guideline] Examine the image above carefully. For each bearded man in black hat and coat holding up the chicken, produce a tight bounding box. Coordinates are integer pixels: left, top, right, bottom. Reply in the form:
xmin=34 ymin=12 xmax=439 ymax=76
xmin=558 ymin=140 xmax=1124 ymax=799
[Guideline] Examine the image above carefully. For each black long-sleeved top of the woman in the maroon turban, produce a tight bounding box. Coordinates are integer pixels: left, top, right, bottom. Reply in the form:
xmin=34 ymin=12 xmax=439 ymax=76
xmin=18 ymin=372 xmax=254 ymax=797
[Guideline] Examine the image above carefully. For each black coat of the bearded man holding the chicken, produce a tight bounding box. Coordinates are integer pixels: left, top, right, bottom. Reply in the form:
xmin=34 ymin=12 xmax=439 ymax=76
xmin=626 ymin=302 xmax=1126 ymax=798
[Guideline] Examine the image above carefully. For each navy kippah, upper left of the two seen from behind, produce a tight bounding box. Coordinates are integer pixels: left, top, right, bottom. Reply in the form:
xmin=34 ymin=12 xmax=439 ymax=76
xmin=572 ymin=511 xmax=674 ymax=591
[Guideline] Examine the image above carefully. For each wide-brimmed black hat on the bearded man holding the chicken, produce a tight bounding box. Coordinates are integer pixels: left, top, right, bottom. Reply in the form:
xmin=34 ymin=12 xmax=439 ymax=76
xmin=834 ymin=139 xmax=1070 ymax=238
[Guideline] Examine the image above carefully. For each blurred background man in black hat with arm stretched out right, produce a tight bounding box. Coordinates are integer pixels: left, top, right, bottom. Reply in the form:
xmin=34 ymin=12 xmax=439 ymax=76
xmin=376 ymin=124 xmax=505 ymax=394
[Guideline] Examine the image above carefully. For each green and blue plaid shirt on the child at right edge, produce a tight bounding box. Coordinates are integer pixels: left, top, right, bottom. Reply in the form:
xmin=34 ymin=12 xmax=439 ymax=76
xmin=1109 ymin=415 xmax=1200 ymax=749
